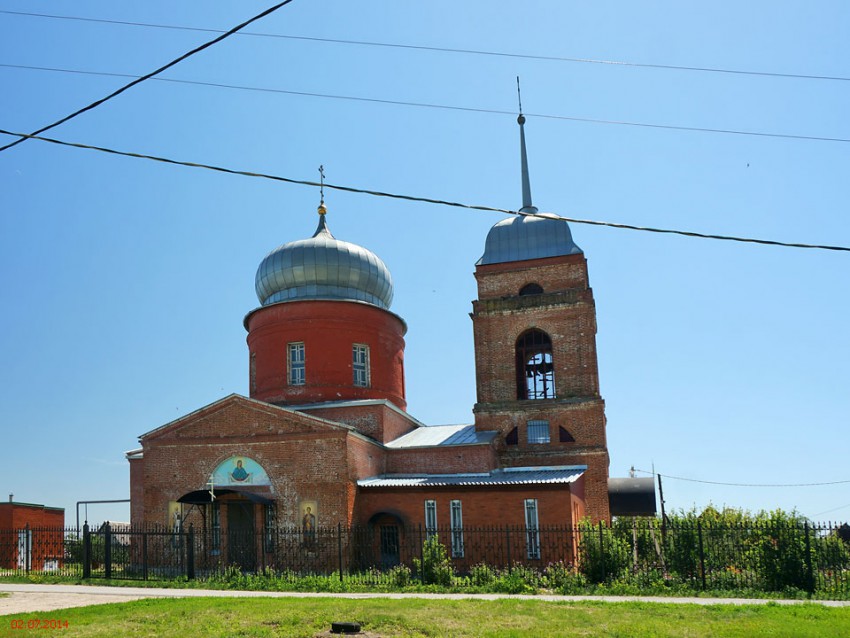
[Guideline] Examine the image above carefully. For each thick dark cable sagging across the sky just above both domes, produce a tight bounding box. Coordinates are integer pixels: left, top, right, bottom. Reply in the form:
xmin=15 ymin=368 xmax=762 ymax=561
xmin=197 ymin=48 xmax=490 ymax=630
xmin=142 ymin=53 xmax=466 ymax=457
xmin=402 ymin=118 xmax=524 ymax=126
xmin=0 ymin=129 xmax=850 ymax=255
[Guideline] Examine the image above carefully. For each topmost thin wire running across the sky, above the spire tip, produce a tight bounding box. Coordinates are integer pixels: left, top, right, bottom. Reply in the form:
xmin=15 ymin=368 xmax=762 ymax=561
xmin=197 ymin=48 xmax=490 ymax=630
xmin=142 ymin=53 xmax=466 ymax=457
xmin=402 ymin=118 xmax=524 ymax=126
xmin=0 ymin=10 xmax=850 ymax=82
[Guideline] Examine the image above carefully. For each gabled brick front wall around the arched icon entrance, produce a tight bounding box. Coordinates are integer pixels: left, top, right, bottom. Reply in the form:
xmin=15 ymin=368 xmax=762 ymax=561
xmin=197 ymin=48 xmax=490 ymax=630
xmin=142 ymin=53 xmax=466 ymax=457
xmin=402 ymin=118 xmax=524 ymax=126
xmin=138 ymin=396 xmax=362 ymax=525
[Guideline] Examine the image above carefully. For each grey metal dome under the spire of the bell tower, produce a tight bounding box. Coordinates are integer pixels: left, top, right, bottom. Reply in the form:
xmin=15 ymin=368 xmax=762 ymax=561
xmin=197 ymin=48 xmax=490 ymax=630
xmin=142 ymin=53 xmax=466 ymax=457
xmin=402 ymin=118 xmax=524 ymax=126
xmin=476 ymin=213 xmax=582 ymax=266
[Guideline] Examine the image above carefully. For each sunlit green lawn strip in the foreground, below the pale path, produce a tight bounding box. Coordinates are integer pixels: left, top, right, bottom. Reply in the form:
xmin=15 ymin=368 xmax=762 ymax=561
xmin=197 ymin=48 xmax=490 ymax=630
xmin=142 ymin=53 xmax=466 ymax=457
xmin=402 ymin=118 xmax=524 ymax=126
xmin=0 ymin=598 xmax=850 ymax=638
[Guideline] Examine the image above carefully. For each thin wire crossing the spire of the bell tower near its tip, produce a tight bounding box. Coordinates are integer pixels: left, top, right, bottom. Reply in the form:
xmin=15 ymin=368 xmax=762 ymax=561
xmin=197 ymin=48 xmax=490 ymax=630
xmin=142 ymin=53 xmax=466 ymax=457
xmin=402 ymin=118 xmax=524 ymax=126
xmin=6 ymin=63 xmax=850 ymax=150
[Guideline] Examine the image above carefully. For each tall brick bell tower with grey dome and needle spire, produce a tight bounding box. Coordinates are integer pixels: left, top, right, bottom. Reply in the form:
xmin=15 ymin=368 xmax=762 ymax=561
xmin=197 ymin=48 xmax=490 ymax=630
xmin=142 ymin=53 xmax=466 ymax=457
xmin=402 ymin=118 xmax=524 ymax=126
xmin=470 ymin=114 xmax=610 ymax=521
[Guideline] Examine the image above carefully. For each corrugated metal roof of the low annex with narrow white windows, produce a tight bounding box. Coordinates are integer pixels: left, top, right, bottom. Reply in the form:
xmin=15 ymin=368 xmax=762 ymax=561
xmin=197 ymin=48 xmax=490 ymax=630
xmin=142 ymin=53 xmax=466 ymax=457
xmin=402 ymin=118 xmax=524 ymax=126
xmin=357 ymin=465 xmax=587 ymax=488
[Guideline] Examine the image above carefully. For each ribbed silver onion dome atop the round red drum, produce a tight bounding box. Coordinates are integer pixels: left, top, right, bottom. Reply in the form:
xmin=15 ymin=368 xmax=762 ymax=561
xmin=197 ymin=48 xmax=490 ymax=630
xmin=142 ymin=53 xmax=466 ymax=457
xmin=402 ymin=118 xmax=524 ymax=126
xmin=256 ymin=205 xmax=393 ymax=310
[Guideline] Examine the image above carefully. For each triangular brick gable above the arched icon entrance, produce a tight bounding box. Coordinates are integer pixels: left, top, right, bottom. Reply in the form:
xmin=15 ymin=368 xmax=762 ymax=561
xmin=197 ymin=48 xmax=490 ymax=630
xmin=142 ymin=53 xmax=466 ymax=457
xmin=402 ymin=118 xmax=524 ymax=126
xmin=139 ymin=394 xmax=352 ymax=443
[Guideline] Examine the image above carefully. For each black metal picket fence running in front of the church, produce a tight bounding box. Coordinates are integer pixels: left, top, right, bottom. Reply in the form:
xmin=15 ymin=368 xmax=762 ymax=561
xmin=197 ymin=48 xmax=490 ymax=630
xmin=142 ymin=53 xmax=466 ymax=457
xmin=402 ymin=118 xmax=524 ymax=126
xmin=0 ymin=519 xmax=850 ymax=598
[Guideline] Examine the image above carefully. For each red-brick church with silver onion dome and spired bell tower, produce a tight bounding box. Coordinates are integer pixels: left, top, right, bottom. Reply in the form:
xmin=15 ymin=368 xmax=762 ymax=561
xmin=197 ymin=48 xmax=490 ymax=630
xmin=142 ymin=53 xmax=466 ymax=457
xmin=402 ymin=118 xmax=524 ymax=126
xmin=126 ymin=115 xmax=654 ymax=568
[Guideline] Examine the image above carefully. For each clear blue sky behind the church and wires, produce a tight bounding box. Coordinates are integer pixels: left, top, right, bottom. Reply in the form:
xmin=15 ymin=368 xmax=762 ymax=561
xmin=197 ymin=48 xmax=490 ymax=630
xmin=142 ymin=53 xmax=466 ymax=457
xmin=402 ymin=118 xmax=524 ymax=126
xmin=0 ymin=0 xmax=850 ymax=522
